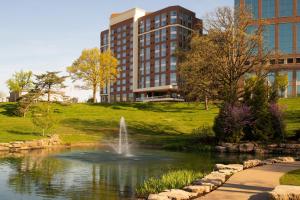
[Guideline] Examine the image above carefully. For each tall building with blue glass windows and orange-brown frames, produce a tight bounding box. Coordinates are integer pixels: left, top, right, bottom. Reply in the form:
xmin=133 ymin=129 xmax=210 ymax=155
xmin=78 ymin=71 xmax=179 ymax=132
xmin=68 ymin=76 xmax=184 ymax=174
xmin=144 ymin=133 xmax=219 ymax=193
xmin=235 ymin=0 xmax=300 ymax=97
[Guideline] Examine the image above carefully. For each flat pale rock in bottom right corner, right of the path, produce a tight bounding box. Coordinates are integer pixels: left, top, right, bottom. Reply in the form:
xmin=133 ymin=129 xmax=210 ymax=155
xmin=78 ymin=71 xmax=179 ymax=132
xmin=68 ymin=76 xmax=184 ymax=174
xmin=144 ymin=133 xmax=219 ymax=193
xmin=270 ymin=185 xmax=300 ymax=200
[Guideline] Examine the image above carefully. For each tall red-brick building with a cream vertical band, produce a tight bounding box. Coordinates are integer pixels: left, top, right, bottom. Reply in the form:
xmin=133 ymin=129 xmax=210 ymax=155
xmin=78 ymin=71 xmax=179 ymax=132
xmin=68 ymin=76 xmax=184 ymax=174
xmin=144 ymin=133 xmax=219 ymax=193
xmin=100 ymin=6 xmax=202 ymax=102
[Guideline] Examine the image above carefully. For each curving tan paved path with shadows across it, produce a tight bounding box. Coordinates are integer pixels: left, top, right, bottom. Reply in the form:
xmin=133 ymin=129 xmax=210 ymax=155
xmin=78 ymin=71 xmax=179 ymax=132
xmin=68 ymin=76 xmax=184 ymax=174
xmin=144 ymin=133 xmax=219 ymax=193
xmin=198 ymin=162 xmax=300 ymax=200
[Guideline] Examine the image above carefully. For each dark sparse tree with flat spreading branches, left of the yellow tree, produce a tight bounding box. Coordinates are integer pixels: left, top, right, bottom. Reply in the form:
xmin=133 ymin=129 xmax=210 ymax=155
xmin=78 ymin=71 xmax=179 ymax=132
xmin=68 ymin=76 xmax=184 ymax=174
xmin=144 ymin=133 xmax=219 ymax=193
xmin=35 ymin=72 xmax=67 ymax=102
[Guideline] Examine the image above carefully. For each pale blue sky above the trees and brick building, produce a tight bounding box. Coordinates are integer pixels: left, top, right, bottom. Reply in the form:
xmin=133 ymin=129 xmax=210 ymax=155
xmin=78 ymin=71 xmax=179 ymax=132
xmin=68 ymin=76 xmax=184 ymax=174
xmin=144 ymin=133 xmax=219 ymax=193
xmin=0 ymin=0 xmax=234 ymax=100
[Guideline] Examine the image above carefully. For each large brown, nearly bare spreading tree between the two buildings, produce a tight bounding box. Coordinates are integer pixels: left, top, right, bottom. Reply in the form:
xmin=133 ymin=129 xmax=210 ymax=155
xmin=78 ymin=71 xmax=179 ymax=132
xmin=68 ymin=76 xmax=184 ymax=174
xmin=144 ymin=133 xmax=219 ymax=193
xmin=178 ymin=7 xmax=270 ymax=105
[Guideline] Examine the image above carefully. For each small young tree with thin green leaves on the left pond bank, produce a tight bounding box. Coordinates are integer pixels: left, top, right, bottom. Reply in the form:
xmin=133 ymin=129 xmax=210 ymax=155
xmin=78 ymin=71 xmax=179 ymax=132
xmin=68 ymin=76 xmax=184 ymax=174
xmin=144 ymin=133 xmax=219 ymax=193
xmin=31 ymin=103 xmax=56 ymax=136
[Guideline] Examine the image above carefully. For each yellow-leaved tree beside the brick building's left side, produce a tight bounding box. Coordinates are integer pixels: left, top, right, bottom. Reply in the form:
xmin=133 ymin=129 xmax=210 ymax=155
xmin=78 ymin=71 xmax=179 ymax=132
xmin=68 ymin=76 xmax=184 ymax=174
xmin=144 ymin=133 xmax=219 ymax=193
xmin=67 ymin=48 xmax=118 ymax=103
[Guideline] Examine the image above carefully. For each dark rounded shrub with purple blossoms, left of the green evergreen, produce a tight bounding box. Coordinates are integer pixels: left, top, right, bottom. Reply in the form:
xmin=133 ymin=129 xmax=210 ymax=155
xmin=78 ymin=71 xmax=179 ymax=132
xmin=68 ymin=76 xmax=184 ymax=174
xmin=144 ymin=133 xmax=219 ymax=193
xmin=213 ymin=104 xmax=252 ymax=142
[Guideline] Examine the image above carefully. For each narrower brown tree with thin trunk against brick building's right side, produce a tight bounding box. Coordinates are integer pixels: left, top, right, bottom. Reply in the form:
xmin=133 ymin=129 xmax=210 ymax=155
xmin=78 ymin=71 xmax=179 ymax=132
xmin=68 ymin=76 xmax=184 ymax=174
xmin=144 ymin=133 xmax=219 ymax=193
xmin=178 ymin=35 xmax=218 ymax=110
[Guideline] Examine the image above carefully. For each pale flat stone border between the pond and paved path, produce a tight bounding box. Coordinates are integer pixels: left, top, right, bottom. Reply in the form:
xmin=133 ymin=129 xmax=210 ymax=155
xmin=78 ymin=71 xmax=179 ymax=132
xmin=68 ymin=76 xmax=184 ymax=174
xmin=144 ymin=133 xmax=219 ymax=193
xmin=147 ymin=157 xmax=295 ymax=200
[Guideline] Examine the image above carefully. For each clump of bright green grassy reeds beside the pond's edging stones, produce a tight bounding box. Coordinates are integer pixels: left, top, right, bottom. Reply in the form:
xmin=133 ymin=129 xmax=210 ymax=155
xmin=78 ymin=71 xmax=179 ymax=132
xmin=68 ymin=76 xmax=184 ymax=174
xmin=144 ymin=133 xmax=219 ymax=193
xmin=136 ymin=170 xmax=203 ymax=197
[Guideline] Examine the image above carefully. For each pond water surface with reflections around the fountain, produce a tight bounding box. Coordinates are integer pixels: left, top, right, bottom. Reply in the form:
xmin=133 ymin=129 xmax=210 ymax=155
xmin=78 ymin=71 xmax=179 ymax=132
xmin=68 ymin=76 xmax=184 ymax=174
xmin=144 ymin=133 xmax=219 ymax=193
xmin=0 ymin=148 xmax=270 ymax=200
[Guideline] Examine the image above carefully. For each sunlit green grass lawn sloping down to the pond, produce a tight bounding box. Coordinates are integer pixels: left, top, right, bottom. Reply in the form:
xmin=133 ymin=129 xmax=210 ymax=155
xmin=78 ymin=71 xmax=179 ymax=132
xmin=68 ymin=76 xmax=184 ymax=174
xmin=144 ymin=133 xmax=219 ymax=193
xmin=0 ymin=98 xmax=300 ymax=145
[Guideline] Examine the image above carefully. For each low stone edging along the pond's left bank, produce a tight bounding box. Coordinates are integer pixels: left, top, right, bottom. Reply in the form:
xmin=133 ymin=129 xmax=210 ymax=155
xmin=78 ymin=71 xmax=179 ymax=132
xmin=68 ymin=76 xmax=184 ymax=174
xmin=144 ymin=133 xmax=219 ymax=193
xmin=0 ymin=135 xmax=61 ymax=152
